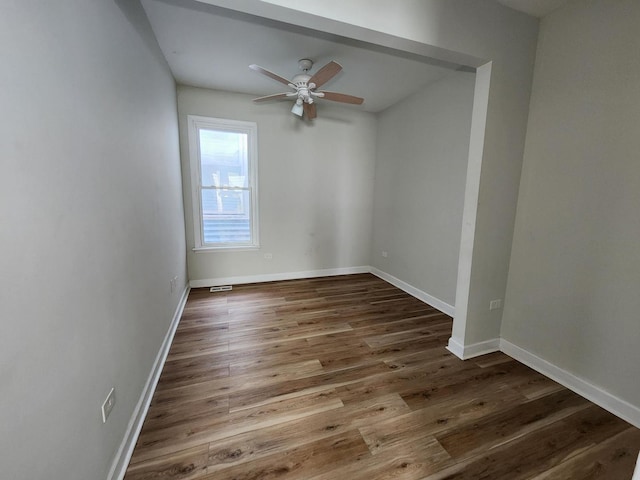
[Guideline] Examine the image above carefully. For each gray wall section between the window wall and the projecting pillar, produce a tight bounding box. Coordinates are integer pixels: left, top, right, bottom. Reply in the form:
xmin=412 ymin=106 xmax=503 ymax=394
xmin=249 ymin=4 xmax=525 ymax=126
xmin=371 ymin=72 xmax=475 ymax=305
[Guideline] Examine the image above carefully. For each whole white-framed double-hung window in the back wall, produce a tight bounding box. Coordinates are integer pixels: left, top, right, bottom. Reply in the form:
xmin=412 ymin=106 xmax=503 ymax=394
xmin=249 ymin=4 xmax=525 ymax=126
xmin=188 ymin=115 xmax=258 ymax=250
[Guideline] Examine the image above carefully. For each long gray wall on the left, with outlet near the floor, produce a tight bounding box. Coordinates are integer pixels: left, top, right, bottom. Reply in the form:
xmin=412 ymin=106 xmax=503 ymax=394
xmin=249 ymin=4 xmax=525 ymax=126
xmin=0 ymin=0 xmax=186 ymax=480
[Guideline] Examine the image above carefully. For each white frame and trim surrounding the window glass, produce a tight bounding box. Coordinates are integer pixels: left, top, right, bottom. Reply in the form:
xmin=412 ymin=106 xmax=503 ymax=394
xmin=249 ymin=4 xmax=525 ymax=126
xmin=187 ymin=115 xmax=260 ymax=252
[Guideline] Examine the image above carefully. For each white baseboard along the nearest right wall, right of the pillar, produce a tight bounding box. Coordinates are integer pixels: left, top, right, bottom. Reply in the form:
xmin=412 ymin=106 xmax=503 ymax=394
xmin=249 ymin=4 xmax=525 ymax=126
xmin=500 ymin=339 xmax=640 ymax=428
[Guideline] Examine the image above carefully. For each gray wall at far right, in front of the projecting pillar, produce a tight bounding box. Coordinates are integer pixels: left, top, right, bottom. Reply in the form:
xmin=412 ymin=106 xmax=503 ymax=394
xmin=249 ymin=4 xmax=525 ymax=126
xmin=502 ymin=0 xmax=640 ymax=406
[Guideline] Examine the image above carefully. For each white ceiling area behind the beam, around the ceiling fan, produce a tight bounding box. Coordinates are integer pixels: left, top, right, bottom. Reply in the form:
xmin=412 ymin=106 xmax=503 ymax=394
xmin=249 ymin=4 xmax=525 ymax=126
xmin=142 ymin=0 xmax=458 ymax=112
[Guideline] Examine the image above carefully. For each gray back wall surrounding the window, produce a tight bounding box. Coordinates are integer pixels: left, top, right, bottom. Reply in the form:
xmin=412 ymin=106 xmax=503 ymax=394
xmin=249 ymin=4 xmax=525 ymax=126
xmin=178 ymin=86 xmax=376 ymax=285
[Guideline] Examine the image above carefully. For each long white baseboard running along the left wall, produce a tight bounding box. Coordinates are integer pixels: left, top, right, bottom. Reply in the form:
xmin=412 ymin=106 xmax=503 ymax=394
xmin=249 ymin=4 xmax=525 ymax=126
xmin=107 ymin=286 xmax=190 ymax=480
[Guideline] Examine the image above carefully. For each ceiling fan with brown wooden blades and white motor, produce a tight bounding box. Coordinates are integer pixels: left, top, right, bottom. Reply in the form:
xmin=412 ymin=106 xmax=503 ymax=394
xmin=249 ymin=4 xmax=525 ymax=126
xmin=249 ymin=58 xmax=364 ymax=120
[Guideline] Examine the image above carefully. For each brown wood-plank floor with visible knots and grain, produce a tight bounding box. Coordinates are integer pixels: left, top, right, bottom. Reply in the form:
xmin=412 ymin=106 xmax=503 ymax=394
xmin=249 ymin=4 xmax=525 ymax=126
xmin=125 ymin=274 xmax=640 ymax=480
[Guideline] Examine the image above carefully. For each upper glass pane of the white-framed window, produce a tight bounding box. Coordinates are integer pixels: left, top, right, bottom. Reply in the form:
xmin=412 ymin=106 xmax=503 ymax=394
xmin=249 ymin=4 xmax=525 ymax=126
xmin=199 ymin=129 xmax=248 ymax=188
